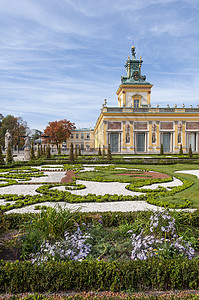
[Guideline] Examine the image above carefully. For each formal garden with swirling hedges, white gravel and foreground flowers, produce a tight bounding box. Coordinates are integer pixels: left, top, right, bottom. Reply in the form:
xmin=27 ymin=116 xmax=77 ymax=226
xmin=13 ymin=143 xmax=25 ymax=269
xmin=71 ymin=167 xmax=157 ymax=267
xmin=0 ymin=155 xmax=199 ymax=299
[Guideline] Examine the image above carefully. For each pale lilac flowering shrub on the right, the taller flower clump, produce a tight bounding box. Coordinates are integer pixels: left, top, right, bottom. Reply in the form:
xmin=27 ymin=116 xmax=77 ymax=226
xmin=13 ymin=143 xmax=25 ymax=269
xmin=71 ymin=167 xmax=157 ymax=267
xmin=128 ymin=211 xmax=195 ymax=260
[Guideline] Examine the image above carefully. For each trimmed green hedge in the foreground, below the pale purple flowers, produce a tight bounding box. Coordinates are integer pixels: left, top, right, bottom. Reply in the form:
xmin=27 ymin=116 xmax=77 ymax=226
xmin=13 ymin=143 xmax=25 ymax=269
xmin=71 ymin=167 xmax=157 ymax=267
xmin=0 ymin=259 xmax=199 ymax=293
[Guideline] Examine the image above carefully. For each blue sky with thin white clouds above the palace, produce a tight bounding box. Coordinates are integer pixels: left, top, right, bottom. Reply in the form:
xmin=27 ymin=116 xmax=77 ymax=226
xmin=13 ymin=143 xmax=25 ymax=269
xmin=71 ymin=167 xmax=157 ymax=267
xmin=0 ymin=0 xmax=199 ymax=130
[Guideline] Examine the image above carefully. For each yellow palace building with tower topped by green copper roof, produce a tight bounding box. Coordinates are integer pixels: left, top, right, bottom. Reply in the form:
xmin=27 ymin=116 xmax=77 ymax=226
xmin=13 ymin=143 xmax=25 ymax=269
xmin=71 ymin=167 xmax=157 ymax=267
xmin=94 ymin=46 xmax=199 ymax=154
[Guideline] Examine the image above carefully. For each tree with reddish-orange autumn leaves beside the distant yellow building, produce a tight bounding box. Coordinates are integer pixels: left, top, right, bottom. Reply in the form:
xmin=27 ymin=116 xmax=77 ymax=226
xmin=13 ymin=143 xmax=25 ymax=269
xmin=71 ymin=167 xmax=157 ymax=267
xmin=44 ymin=119 xmax=76 ymax=149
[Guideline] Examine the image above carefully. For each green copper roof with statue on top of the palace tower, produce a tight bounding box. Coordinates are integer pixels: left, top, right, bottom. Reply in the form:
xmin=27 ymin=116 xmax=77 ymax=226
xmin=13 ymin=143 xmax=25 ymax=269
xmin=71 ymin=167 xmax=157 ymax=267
xmin=121 ymin=46 xmax=150 ymax=85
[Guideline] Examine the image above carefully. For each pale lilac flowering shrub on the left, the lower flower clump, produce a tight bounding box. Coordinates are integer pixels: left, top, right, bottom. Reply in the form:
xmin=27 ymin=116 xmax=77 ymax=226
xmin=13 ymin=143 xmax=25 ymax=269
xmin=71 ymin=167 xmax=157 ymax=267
xmin=31 ymin=225 xmax=91 ymax=264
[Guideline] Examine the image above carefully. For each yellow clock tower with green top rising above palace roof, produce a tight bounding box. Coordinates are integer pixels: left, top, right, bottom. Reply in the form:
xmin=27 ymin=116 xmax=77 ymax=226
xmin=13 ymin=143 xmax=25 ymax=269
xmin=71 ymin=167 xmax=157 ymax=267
xmin=116 ymin=46 xmax=153 ymax=108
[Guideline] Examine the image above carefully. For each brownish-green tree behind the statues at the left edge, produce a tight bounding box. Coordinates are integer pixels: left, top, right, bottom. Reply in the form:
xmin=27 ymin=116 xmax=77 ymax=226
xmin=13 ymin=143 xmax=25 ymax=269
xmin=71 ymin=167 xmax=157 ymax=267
xmin=0 ymin=115 xmax=29 ymax=148
